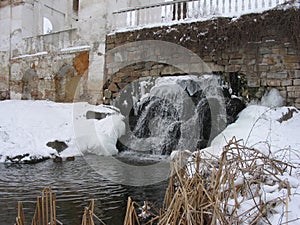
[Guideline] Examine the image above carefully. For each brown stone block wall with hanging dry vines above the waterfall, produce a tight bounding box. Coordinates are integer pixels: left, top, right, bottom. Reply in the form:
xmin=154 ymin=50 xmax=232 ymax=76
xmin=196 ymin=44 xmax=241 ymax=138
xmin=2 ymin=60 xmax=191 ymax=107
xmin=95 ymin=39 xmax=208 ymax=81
xmin=104 ymin=8 xmax=300 ymax=108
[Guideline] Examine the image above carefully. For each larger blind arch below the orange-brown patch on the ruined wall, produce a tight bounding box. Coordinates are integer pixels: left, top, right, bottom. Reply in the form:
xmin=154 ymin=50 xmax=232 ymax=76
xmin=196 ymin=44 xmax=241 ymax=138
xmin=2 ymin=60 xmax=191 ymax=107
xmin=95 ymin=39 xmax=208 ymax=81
xmin=55 ymin=65 xmax=81 ymax=102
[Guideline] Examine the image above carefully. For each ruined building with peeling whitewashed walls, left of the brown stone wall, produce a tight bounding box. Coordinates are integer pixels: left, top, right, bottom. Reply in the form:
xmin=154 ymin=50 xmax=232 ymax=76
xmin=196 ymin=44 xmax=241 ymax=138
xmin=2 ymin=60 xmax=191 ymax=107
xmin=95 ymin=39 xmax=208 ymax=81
xmin=0 ymin=0 xmax=158 ymax=103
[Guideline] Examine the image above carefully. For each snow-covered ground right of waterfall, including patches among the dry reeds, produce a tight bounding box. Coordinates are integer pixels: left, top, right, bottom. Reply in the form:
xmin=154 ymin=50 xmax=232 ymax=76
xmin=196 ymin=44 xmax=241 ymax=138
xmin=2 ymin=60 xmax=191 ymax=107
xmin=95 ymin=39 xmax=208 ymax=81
xmin=199 ymin=89 xmax=300 ymax=225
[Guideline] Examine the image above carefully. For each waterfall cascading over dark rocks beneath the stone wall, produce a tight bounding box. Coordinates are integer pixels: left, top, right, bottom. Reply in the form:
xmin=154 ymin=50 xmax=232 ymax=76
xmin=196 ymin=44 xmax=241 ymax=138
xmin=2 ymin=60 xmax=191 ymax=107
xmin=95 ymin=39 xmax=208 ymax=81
xmin=115 ymin=75 xmax=244 ymax=155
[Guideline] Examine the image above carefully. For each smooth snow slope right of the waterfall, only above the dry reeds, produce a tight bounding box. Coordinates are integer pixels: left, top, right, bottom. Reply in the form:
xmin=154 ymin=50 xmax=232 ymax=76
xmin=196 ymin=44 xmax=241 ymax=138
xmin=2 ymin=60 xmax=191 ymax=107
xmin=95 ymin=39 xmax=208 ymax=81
xmin=207 ymin=90 xmax=300 ymax=160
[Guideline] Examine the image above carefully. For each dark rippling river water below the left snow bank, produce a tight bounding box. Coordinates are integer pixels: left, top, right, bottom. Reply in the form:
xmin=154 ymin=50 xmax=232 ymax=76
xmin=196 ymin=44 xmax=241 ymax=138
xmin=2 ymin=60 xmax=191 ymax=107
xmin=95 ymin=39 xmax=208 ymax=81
xmin=0 ymin=155 xmax=169 ymax=225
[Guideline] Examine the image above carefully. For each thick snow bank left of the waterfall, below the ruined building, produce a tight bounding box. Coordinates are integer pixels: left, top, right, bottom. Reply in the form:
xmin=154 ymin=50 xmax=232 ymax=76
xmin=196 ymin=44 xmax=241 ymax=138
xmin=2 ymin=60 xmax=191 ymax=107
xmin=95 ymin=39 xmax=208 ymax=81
xmin=0 ymin=100 xmax=125 ymax=162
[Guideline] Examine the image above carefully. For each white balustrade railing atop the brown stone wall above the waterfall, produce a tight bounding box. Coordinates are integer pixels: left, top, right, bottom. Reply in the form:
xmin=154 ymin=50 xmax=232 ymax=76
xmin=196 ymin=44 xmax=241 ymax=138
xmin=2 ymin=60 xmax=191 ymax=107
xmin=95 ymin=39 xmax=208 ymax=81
xmin=113 ymin=0 xmax=287 ymax=30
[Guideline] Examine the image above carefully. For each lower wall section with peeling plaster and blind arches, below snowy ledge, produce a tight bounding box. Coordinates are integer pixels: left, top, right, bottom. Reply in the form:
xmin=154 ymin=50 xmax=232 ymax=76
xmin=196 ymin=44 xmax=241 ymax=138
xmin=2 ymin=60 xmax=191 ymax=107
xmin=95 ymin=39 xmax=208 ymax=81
xmin=9 ymin=51 xmax=89 ymax=102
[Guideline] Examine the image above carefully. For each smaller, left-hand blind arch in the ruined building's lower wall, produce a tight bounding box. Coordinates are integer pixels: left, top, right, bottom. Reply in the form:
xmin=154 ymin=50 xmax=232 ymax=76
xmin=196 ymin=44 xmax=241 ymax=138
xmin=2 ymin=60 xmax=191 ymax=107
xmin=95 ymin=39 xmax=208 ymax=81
xmin=22 ymin=69 xmax=39 ymax=100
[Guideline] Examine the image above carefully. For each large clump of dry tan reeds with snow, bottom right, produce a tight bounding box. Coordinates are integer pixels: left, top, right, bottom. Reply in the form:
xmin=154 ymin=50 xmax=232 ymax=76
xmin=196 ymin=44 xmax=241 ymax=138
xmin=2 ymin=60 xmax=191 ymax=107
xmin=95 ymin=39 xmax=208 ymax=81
xmin=124 ymin=138 xmax=293 ymax=225
